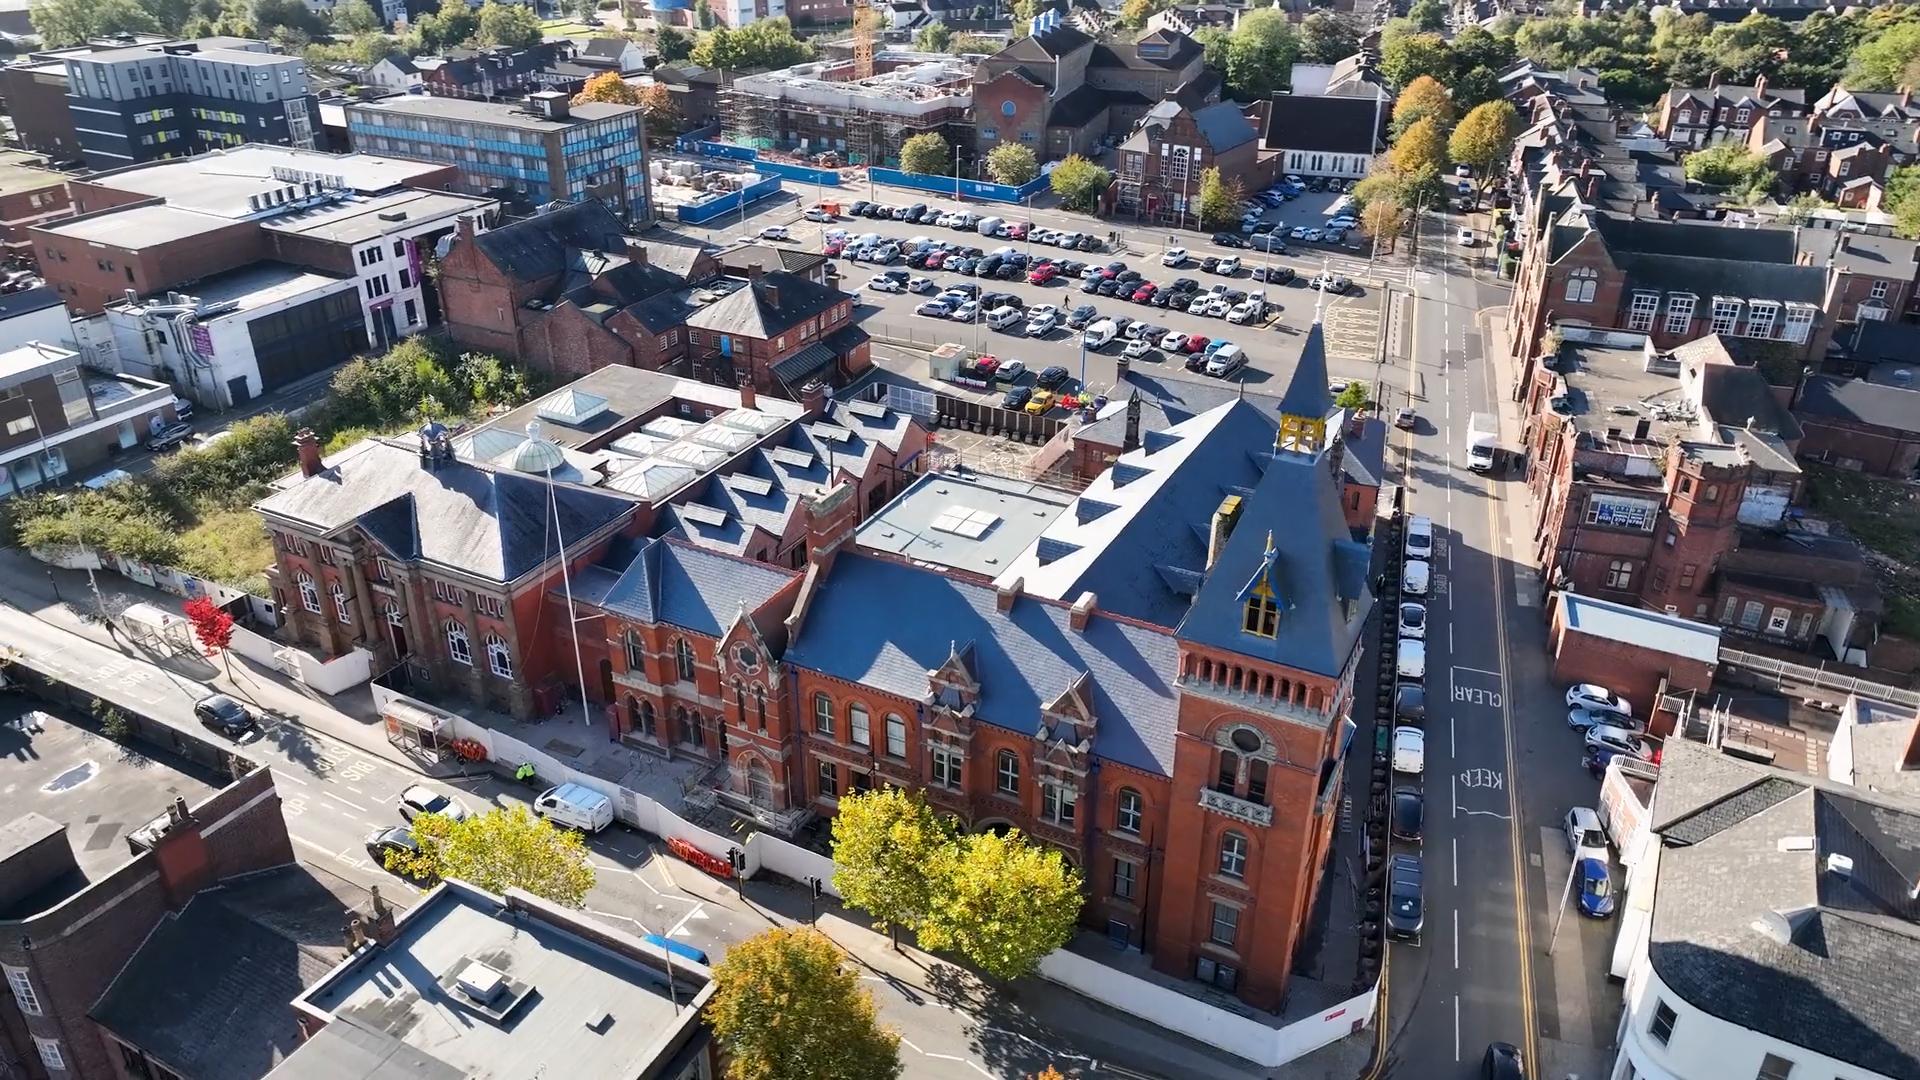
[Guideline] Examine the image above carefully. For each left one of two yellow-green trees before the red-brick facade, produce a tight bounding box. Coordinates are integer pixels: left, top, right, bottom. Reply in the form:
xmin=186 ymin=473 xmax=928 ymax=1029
xmin=833 ymin=788 xmax=956 ymax=947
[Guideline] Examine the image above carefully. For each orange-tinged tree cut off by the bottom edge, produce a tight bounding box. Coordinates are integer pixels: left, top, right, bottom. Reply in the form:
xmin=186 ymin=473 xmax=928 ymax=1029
xmin=707 ymin=926 xmax=900 ymax=1080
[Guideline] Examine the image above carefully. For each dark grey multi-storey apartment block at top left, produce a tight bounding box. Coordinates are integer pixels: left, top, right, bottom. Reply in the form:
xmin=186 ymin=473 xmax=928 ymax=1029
xmin=65 ymin=38 xmax=319 ymax=169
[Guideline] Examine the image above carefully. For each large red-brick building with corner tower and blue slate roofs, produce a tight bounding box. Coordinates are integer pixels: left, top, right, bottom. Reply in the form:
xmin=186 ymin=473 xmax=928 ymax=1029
xmin=263 ymin=325 xmax=1373 ymax=1009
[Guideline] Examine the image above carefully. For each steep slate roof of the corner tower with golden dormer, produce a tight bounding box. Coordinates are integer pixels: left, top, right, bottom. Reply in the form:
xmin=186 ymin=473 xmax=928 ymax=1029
xmin=1179 ymin=438 xmax=1373 ymax=676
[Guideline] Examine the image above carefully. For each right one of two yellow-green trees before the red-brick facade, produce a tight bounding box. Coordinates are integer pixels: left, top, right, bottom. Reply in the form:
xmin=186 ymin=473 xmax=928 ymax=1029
xmin=920 ymin=830 xmax=1085 ymax=978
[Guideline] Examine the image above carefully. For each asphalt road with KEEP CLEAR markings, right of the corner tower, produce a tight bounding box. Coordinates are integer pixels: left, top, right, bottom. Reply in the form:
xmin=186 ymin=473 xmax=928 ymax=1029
xmin=1382 ymin=217 xmax=1619 ymax=1078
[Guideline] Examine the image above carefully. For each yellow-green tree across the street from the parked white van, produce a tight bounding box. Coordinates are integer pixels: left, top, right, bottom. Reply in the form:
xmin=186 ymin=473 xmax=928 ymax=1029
xmin=386 ymin=805 xmax=593 ymax=907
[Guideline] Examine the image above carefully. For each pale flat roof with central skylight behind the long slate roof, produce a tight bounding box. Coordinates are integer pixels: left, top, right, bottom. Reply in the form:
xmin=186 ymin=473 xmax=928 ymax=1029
xmin=854 ymin=473 xmax=1073 ymax=578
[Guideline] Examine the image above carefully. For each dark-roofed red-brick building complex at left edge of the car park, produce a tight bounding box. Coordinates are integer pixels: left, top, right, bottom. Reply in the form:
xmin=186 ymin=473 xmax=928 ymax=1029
xmin=440 ymin=200 xmax=872 ymax=396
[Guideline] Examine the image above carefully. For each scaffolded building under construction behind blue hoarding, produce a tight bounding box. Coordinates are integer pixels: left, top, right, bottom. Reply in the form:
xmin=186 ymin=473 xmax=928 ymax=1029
xmin=726 ymin=50 xmax=973 ymax=167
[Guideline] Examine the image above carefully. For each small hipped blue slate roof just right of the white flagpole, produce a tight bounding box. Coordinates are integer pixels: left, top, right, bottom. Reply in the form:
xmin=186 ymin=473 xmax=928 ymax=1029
xmin=595 ymin=540 xmax=797 ymax=638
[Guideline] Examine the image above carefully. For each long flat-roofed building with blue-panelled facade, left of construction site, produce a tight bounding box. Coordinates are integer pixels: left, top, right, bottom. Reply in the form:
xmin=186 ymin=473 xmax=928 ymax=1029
xmin=348 ymin=90 xmax=653 ymax=225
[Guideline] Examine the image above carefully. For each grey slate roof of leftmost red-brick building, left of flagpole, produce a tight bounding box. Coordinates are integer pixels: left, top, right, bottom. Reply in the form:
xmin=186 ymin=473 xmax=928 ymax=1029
xmin=253 ymin=438 xmax=636 ymax=582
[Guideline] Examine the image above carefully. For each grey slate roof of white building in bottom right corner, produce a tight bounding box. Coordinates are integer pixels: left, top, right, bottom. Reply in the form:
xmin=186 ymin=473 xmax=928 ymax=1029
xmin=1647 ymin=740 xmax=1920 ymax=1080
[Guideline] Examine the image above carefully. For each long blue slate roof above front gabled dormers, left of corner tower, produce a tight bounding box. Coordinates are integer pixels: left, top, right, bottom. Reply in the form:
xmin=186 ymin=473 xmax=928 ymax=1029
xmin=787 ymin=552 xmax=1179 ymax=776
